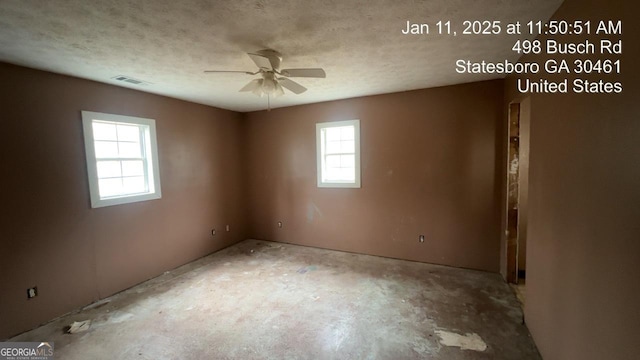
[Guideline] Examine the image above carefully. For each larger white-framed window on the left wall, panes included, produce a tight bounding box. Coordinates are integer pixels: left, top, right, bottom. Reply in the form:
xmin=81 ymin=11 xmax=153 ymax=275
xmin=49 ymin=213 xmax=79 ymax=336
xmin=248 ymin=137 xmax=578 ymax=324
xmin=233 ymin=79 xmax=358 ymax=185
xmin=82 ymin=111 xmax=161 ymax=208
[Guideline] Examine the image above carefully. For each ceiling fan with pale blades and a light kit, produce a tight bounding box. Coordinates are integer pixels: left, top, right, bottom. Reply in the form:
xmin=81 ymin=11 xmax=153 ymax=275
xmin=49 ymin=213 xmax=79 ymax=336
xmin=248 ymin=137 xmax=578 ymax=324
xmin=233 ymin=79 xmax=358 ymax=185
xmin=205 ymin=49 xmax=327 ymax=108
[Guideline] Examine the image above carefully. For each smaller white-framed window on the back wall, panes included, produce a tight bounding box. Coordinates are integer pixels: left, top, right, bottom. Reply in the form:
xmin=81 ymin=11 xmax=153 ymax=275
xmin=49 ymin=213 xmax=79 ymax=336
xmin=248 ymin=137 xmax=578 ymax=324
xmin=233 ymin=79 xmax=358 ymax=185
xmin=316 ymin=120 xmax=360 ymax=188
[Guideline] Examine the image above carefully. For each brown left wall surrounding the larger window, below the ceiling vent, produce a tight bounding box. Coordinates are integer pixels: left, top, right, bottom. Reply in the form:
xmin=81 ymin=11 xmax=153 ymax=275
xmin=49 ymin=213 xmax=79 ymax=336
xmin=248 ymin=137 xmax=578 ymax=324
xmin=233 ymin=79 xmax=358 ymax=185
xmin=0 ymin=64 xmax=246 ymax=339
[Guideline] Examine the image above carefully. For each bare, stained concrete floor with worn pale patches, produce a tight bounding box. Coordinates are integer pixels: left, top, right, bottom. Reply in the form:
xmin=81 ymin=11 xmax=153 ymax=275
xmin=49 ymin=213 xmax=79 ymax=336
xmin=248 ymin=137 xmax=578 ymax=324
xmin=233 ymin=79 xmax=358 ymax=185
xmin=11 ymin=240 xmax=540 ymax=360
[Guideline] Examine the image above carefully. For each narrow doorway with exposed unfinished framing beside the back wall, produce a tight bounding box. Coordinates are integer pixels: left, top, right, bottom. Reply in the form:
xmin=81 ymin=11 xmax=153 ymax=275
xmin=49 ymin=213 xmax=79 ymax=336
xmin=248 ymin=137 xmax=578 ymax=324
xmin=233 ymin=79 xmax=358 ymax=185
xmin=505 ymin=98 xmax=530 ymax=305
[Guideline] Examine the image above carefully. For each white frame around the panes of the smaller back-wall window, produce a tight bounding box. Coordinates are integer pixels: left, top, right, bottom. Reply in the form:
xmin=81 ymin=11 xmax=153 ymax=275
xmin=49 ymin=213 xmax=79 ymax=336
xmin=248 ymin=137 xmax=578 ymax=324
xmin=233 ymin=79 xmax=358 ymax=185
xmin=316 ymin=120 xmax=360 ymax=188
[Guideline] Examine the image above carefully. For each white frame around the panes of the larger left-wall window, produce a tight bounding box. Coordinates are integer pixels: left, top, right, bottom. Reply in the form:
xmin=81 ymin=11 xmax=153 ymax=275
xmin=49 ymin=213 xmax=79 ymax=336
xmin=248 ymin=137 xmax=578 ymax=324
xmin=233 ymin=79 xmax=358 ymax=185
xmin=82 ymin=111 xmax=162 ymax=208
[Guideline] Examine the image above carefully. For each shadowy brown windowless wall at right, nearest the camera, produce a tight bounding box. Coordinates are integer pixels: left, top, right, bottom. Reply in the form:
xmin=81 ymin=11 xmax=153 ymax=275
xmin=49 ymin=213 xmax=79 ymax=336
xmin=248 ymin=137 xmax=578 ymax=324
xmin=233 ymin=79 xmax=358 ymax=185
xmin=506 ymin=0 xmax=640 ymax=360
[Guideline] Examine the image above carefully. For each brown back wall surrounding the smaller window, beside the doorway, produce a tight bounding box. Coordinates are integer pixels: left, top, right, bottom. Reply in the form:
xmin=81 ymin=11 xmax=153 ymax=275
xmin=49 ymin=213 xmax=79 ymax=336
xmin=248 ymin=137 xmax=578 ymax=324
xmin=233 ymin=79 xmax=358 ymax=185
xmin=246 ymin=80 xmax=504 ymax=272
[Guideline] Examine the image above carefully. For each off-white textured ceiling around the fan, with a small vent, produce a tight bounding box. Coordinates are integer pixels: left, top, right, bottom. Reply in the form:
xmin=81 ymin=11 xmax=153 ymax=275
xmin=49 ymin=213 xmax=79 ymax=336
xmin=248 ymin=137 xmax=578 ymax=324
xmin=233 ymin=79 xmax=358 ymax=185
xmin=0 ymin=0 xmax=562 ymax=112
